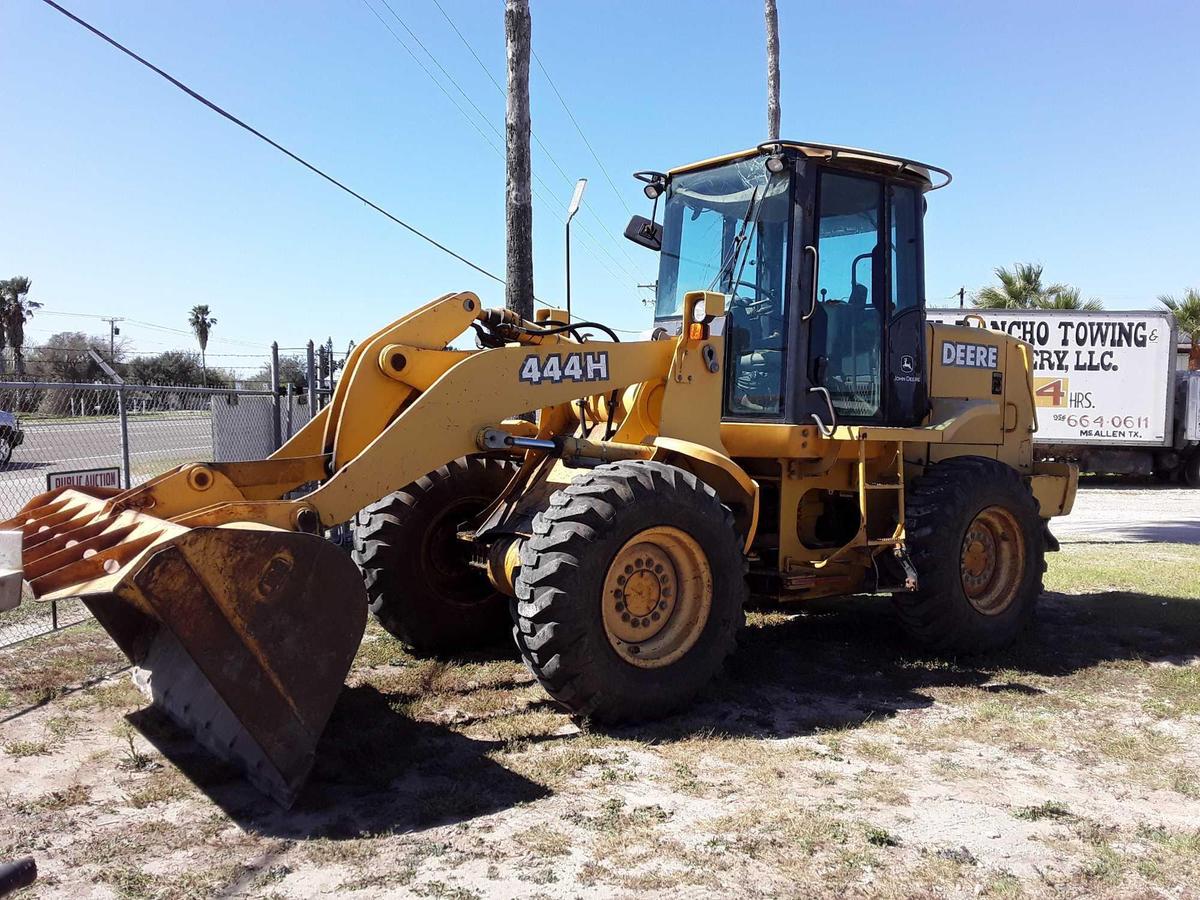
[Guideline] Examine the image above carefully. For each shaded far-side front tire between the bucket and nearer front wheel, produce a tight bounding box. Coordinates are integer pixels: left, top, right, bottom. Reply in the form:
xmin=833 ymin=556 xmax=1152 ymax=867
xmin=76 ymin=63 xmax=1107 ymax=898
xmin=353 ymin=456 xmax=516 ymax=654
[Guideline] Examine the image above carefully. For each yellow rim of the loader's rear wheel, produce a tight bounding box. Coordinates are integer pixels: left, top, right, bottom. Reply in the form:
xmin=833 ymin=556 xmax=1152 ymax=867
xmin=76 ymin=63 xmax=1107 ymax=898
xmin=959 ymin=506 xmax=1025 ymax=616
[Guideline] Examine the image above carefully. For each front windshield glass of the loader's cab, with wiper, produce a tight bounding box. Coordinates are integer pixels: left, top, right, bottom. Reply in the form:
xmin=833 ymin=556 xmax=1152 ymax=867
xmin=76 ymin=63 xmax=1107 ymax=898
xmin=654 ymin=156 xmax=792 ymax=418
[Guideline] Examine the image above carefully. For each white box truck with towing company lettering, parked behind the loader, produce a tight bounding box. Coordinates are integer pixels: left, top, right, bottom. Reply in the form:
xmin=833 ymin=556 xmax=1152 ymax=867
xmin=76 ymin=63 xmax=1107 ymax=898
xmin=928 ymin=310 xmax=1200 ymax=487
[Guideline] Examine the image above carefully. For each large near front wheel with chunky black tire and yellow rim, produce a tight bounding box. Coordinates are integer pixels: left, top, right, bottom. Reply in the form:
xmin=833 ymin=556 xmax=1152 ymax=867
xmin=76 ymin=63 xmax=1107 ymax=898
xmin=512 ymin=460 xmax=748 ymax=724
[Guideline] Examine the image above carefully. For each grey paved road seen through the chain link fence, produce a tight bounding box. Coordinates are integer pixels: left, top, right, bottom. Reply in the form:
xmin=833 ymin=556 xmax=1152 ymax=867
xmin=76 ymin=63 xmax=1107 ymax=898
xmin=0 ymin=414 xmax=212 ymax=516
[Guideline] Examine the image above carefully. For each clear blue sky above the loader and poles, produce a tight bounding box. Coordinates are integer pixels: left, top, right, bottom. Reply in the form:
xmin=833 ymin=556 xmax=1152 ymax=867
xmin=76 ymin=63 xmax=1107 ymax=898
xmin=0 ymin=0 xmax=1200 ymax=366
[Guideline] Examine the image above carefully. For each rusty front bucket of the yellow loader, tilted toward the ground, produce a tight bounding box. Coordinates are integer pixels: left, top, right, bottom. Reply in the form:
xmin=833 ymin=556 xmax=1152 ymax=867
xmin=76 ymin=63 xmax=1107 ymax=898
xmin=8 ymin=494 xmax=366 ymax=806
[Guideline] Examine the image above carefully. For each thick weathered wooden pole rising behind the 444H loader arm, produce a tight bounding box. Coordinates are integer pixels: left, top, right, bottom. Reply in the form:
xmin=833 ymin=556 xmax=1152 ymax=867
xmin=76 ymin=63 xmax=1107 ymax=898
xmin=504 ymin=0 xmax=533 ymax=320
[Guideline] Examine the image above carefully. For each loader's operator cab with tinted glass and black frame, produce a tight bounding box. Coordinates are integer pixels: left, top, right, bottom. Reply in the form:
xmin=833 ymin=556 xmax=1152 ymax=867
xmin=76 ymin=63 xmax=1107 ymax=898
xmin=625 ymin=142 xmax=950 ymax=428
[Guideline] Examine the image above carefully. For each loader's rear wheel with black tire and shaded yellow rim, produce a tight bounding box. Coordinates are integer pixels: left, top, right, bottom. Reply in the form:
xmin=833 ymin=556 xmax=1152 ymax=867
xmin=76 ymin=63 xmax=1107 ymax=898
xmin=894 ymin=456 xmax=1045 ymax=653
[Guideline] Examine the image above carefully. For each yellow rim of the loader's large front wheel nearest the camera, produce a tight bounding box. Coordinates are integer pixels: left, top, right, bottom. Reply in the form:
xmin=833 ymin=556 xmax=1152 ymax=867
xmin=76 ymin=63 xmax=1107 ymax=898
xmin=601 ymin=526 xmax=713 ymax=668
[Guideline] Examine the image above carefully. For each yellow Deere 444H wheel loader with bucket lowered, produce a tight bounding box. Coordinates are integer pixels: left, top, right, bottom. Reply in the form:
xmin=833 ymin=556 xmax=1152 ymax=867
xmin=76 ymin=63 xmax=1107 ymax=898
xmin=2 ymin=142 xmax=1076 ymax=804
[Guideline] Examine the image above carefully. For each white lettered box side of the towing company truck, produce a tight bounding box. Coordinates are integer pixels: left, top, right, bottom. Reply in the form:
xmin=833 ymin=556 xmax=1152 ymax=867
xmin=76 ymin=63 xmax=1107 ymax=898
xmin=928 ymin=310 xmax=1175 ymax=446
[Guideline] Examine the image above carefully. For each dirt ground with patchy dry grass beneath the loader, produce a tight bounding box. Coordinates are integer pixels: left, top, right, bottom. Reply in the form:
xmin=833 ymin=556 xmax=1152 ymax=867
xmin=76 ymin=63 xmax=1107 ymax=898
xmin=0 ymin=544 xmax=1200 ymax=898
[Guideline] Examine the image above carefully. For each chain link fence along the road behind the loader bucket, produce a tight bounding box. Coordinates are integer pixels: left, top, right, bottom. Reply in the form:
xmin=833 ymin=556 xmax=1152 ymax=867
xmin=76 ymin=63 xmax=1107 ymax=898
xmin=0 ymin=382 xmax=321 ymax=647
